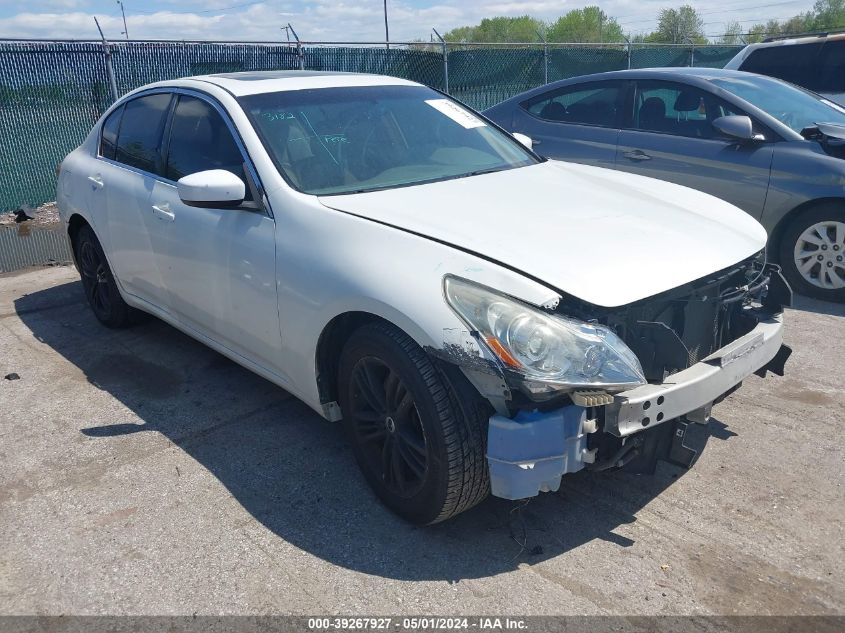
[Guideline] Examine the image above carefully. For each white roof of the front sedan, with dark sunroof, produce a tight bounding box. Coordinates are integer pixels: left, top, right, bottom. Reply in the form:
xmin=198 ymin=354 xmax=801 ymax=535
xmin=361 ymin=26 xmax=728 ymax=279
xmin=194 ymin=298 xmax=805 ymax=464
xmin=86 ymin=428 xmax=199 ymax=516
xmin=151 ymin=70 xmax=419 ymax=97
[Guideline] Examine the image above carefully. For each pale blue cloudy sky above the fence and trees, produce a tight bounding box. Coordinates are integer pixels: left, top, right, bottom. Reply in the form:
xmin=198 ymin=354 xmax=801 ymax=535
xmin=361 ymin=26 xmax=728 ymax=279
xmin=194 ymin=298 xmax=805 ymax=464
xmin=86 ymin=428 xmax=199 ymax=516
xmin=0 ymin=0 xmax=813 ymax=41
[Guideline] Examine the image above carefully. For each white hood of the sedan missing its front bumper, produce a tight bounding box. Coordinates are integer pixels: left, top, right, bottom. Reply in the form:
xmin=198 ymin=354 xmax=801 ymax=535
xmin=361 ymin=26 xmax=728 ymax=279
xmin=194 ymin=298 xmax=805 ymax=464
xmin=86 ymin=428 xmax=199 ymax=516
xmin=320 ymin=161 xmax=766 ymax=307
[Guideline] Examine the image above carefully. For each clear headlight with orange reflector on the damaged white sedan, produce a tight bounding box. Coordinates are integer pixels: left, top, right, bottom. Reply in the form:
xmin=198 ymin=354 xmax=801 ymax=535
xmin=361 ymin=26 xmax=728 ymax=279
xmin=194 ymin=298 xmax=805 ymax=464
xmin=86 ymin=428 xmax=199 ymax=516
xmin=444 ymin=276 xmax=646 ymax=389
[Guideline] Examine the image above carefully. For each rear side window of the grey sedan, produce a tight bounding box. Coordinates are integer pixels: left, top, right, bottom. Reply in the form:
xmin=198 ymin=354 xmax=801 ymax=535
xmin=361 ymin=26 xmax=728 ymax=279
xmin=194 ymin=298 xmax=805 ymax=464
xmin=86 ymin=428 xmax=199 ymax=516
xmin=521 ymin=81 xmax=625 ymax=127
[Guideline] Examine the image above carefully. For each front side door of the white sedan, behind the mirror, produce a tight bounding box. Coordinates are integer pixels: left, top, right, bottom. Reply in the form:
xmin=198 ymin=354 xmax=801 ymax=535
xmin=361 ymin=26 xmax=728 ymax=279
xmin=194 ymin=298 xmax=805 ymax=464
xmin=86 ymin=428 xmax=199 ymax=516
xmin=144 ymin=94 xmax=281 ymax=368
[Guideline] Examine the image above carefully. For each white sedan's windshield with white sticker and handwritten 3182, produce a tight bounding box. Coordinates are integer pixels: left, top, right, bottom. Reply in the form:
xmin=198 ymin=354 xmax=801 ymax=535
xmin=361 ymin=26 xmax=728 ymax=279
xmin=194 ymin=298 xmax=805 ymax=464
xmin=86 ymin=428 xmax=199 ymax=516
xmin=240 ymin=86 xmax=538 ymax=195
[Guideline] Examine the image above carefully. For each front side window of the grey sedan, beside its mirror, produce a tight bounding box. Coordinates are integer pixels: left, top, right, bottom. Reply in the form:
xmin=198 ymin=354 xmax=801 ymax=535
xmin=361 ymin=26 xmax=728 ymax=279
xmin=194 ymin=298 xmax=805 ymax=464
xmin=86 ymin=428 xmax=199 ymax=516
xmin=631 ymin=81 xmax=744 ymax=138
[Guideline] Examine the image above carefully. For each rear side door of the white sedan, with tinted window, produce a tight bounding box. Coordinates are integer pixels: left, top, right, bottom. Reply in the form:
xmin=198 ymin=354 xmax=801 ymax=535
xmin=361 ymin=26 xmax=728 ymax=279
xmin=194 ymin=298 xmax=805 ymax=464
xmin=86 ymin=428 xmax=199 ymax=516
xmin=88 ymin=93 xmax=171 ymax=309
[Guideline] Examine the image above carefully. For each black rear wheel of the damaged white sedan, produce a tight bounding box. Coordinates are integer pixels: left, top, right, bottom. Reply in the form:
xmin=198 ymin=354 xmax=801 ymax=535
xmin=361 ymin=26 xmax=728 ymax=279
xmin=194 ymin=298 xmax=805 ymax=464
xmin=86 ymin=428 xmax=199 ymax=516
xmin=74 ymin=226 xmax=137 ymax=328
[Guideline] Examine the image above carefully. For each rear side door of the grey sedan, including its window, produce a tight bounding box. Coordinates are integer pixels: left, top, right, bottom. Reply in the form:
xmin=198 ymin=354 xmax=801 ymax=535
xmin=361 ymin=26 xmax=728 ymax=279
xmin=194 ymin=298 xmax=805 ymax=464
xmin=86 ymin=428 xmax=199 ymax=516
xmin=513 ymin=80 xmax=628 ymax=167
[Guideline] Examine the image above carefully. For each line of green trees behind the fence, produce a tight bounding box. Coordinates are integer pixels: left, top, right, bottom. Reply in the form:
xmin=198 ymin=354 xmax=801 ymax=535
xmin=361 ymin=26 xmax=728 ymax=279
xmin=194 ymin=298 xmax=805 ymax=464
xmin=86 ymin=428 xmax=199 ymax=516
xmin=443 ymin=0 xmax=845 ymax=45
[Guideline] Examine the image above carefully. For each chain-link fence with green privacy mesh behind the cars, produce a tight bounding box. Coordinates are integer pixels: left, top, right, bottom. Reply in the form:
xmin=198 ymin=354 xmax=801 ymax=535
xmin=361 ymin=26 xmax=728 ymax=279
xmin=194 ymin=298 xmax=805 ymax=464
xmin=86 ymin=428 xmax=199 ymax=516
xmin=0 ymin=41 xmax=740 ymax=211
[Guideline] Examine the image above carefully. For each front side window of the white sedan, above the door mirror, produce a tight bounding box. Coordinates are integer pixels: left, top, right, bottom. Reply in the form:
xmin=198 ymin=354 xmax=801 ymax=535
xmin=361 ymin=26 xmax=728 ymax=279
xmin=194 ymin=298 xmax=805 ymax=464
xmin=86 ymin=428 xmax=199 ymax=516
xmin=165 ymin=95 xmax=249 ymax=194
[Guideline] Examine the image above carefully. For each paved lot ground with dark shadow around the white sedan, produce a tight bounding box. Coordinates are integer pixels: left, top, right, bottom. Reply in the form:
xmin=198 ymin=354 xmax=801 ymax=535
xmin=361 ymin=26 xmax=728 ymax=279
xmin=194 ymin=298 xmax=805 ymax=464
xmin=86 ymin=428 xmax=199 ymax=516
xmin=0 ymin=268 xmax=845 ymax=615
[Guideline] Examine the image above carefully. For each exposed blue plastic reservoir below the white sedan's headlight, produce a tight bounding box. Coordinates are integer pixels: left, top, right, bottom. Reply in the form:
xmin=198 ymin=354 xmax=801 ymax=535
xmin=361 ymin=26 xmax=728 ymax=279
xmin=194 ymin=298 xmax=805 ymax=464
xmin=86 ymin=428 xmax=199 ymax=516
xmin=487 ymin=405 xmax=587 ymax=499
